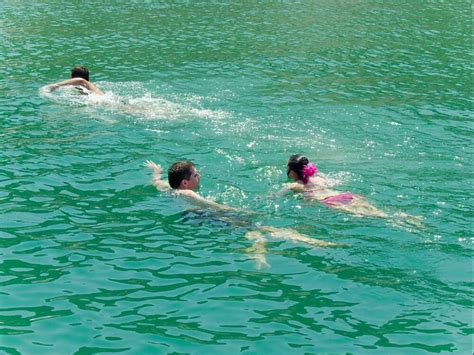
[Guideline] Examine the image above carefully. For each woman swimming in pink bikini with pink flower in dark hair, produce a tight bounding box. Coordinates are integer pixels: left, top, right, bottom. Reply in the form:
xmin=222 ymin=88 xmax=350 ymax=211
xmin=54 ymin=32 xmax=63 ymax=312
xmin=282 ymin=154 xmax=388 ymax=218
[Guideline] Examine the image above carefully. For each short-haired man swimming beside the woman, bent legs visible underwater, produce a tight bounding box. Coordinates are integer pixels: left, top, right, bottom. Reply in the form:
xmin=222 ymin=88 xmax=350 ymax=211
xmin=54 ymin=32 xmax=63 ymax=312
xmin=144 ymin=160 xmax=337 ymax=269
